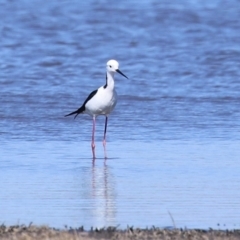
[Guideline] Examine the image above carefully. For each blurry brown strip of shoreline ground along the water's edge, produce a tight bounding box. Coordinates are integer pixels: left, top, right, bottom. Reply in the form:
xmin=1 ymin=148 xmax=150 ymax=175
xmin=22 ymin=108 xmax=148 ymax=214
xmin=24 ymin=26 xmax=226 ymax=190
xmin=0 ymin=225 xmax=240 ymax=240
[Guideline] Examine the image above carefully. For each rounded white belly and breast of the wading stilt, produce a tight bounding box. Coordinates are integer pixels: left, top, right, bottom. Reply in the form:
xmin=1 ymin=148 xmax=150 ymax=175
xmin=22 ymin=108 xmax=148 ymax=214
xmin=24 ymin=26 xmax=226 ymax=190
xmin=85 ymin=87 xmax=117 ymax=116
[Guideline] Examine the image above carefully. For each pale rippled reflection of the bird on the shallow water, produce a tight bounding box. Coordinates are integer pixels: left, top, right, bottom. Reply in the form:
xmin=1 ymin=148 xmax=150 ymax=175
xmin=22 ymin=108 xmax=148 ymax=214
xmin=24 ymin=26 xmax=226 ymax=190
xmin=92 ymin=162 xmax=116 ymax=227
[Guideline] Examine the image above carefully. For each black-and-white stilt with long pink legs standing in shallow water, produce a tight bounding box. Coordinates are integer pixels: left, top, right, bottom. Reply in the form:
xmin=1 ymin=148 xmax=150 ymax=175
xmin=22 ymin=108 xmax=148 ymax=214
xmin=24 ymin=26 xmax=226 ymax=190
xmin=65 ymin=60 xmax=128 ymax=159
